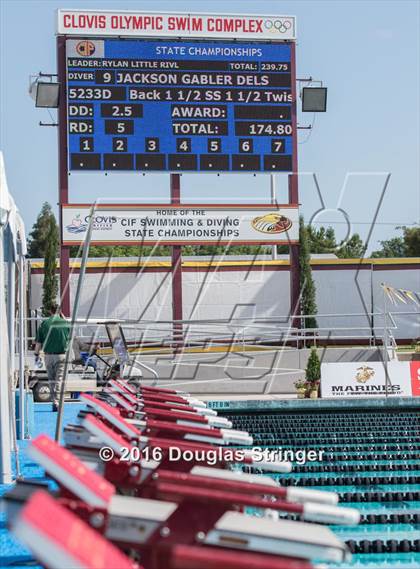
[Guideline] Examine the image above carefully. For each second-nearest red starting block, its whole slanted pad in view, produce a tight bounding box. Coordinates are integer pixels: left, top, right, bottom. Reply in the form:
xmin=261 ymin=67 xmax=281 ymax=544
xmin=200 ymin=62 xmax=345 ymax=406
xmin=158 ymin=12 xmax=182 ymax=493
xmin=23 ymin=436 xmax=358 ymax=560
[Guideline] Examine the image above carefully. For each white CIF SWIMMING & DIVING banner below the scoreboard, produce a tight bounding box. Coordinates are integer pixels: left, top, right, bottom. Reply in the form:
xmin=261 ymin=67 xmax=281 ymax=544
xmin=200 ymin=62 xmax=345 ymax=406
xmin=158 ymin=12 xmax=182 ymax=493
xmin=62 ymin=204 xmax=299 ymax=245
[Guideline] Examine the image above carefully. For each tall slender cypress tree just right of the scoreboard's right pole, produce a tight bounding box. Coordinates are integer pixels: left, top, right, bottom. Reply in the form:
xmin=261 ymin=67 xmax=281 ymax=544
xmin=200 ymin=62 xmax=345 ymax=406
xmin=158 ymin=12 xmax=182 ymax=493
xmin=299 ymin=217 xmax=318 ymax=328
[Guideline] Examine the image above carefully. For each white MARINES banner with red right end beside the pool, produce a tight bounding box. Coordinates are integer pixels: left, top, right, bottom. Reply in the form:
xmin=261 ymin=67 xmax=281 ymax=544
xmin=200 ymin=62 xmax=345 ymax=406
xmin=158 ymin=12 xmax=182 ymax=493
xmin=321 ymin=361 xmax=420 ymax=398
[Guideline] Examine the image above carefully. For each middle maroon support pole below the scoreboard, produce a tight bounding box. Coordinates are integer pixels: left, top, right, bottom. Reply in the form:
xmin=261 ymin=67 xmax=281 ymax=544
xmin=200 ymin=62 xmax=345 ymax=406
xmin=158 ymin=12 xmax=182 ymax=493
xmin=170 ymin=174 xmax=183 ymax=346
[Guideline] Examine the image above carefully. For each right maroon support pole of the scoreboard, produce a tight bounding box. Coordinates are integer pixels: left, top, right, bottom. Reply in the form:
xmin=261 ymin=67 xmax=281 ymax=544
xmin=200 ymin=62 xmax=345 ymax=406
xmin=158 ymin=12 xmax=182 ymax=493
xmin=288 ymin=42 xmax=301 ymax=328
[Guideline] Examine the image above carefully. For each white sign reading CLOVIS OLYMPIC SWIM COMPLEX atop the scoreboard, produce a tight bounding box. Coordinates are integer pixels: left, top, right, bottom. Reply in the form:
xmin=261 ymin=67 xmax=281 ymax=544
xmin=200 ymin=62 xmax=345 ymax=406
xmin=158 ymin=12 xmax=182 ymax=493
xmin=57 ymin=10 xmax=296 ymax=41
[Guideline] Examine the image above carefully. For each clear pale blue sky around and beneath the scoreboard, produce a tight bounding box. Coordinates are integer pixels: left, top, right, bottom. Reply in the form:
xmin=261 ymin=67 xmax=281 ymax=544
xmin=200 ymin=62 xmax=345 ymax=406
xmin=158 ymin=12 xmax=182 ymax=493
xmin=0 ymin=0 xmax=420 ymax=249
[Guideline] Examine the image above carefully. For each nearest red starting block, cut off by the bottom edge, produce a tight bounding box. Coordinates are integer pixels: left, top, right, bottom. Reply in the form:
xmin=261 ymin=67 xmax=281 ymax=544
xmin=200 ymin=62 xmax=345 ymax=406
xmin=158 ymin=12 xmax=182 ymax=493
xmin=13 ymin=491 xmax=313 ymax=569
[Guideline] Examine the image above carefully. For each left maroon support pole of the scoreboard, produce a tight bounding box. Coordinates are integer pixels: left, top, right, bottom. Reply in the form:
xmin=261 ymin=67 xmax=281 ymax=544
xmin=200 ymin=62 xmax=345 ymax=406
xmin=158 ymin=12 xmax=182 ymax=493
xmin=57 ymin=36 xmax=70 ymax=317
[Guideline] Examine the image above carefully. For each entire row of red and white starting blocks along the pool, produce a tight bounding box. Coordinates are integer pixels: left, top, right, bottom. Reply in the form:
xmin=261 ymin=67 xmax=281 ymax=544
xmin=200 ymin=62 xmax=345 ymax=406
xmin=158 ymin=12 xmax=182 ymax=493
xmin=5 ymin=379 xmax=359 ymax=569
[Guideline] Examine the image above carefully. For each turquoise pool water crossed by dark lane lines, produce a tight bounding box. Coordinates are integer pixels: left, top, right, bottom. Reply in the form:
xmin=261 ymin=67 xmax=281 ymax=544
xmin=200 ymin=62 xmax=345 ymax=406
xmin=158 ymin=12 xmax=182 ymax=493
xmin=223 ymin=401 xmax=420 ymax=569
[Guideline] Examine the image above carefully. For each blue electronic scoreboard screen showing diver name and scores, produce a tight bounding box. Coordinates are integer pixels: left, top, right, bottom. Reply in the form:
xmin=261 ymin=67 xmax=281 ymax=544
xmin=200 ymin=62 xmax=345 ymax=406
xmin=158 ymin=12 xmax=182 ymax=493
xmin=66 ymin=39 xmax=296 ymax=172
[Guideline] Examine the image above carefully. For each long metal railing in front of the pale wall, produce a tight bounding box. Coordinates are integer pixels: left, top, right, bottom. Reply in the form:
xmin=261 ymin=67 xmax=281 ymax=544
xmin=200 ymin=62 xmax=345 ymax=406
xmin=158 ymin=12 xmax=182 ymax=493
xmin=21 ymin=311 xmax=406 ymax=352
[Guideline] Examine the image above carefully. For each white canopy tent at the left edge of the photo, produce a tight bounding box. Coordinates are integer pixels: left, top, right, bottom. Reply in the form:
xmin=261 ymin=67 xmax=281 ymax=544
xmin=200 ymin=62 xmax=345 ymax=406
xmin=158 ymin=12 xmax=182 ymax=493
xmin=0 ymin=151 xmax=26 ymax=484
